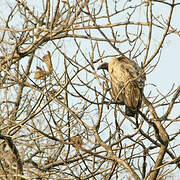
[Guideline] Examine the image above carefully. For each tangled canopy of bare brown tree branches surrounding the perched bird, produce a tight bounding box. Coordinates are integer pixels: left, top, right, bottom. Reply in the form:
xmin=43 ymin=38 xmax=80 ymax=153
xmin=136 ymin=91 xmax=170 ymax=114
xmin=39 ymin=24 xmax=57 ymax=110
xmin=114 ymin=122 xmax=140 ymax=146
xmin=0 ymin=0 xmax=180 ymax=180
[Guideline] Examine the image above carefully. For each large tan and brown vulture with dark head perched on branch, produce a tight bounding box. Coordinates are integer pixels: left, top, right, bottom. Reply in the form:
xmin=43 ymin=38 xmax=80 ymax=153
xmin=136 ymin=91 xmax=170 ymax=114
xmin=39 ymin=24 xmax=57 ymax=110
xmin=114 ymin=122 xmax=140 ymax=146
xmin=98 ymin=56 xmax=146 ymax=117
